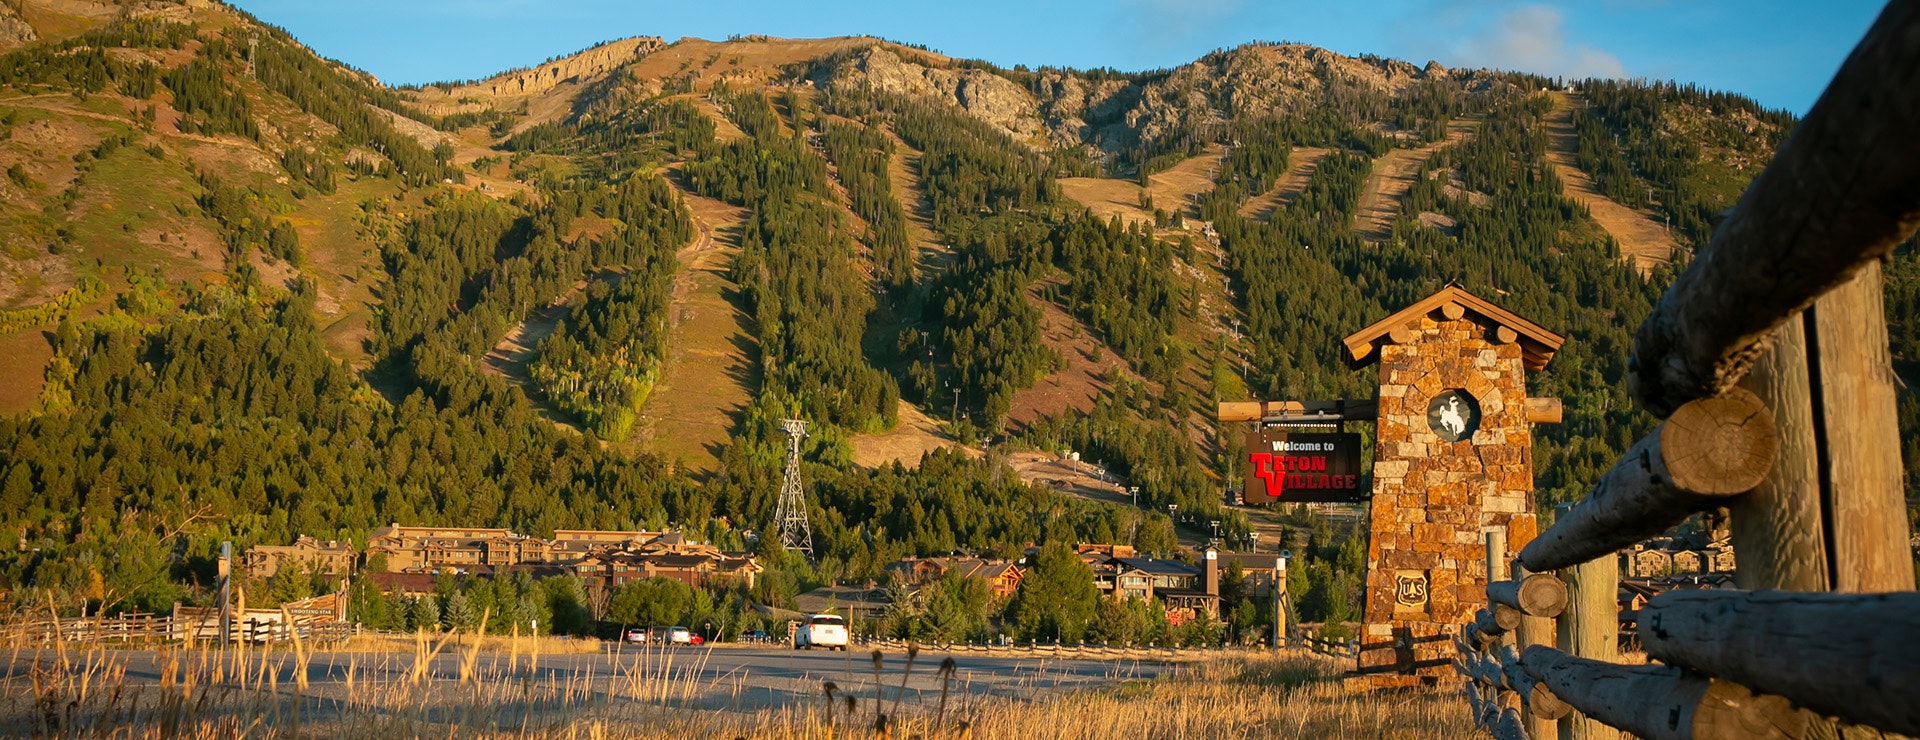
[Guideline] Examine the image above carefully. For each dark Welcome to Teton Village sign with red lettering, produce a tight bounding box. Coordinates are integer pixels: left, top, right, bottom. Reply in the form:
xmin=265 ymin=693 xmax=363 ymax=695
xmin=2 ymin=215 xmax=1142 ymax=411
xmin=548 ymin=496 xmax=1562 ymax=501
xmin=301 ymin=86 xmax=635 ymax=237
xmin=1246 ymin=429 xmax=1367 ymax=504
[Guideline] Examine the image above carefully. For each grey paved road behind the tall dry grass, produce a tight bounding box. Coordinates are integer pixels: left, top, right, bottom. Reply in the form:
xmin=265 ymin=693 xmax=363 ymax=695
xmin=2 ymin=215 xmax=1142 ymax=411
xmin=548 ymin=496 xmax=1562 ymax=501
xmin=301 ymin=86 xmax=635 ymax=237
xmin=0 ymin=646 xmax=1167 ymax=709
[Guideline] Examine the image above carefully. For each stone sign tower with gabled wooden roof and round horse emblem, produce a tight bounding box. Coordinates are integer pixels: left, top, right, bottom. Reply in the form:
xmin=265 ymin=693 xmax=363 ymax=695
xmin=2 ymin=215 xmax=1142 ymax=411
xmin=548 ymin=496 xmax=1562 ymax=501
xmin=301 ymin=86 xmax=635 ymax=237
xmin=1344 ymin=284 xmax=1565 ymax=684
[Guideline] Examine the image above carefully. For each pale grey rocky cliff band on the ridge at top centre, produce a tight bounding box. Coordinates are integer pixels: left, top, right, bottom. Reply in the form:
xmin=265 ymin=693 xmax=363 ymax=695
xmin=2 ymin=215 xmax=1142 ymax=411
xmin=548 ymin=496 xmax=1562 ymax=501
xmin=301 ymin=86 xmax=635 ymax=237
xmin=829 ymin=46 xmax=1043 ymax=142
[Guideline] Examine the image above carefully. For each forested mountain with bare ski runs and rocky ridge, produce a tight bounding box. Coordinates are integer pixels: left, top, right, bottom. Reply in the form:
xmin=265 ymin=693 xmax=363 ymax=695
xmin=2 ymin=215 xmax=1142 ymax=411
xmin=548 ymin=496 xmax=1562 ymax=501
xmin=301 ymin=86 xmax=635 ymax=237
xmin=0 ymin=0 xmax=1920 ymax=605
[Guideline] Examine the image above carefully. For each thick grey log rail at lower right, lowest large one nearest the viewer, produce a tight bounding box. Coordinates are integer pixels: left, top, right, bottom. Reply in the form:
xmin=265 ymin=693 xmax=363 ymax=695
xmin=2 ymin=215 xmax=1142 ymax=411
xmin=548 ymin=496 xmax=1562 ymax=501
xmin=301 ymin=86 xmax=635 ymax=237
xmin=1640 ymin=590 xmax=1920 ymax=736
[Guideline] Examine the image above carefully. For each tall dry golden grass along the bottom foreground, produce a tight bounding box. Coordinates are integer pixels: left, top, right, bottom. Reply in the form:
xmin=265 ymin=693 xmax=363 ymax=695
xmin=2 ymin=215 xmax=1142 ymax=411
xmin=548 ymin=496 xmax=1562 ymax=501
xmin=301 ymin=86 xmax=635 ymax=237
xmin=0 ymin=622 xmax=1473 ymax=740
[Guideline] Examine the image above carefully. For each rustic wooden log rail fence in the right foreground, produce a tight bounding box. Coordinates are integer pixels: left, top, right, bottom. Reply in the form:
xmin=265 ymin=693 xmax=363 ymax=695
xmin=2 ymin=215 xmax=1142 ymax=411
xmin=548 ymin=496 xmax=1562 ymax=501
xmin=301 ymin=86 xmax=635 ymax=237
xmin=1455 ymin=0 xmax=1920 ymax=740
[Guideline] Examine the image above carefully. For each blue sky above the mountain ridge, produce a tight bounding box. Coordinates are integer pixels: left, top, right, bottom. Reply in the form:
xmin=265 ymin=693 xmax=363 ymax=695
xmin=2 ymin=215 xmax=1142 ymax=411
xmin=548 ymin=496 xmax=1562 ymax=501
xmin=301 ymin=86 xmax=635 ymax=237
xmin=234 ymin=0 xmax=1882 ymax=113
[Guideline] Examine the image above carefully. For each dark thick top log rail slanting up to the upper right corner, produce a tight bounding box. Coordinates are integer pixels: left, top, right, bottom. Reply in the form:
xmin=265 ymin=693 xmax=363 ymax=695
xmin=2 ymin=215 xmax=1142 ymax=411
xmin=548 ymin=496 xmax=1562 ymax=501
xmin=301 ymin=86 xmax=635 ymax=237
xmin=1626 ymin=0 xmax=1920 ymax=417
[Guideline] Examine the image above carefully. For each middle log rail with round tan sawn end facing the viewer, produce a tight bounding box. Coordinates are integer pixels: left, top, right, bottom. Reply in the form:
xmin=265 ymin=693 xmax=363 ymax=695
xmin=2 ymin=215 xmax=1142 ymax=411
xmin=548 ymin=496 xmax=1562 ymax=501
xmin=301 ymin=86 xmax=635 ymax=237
xmin=1519 ymin=386 xmax=1774 ymax=573
